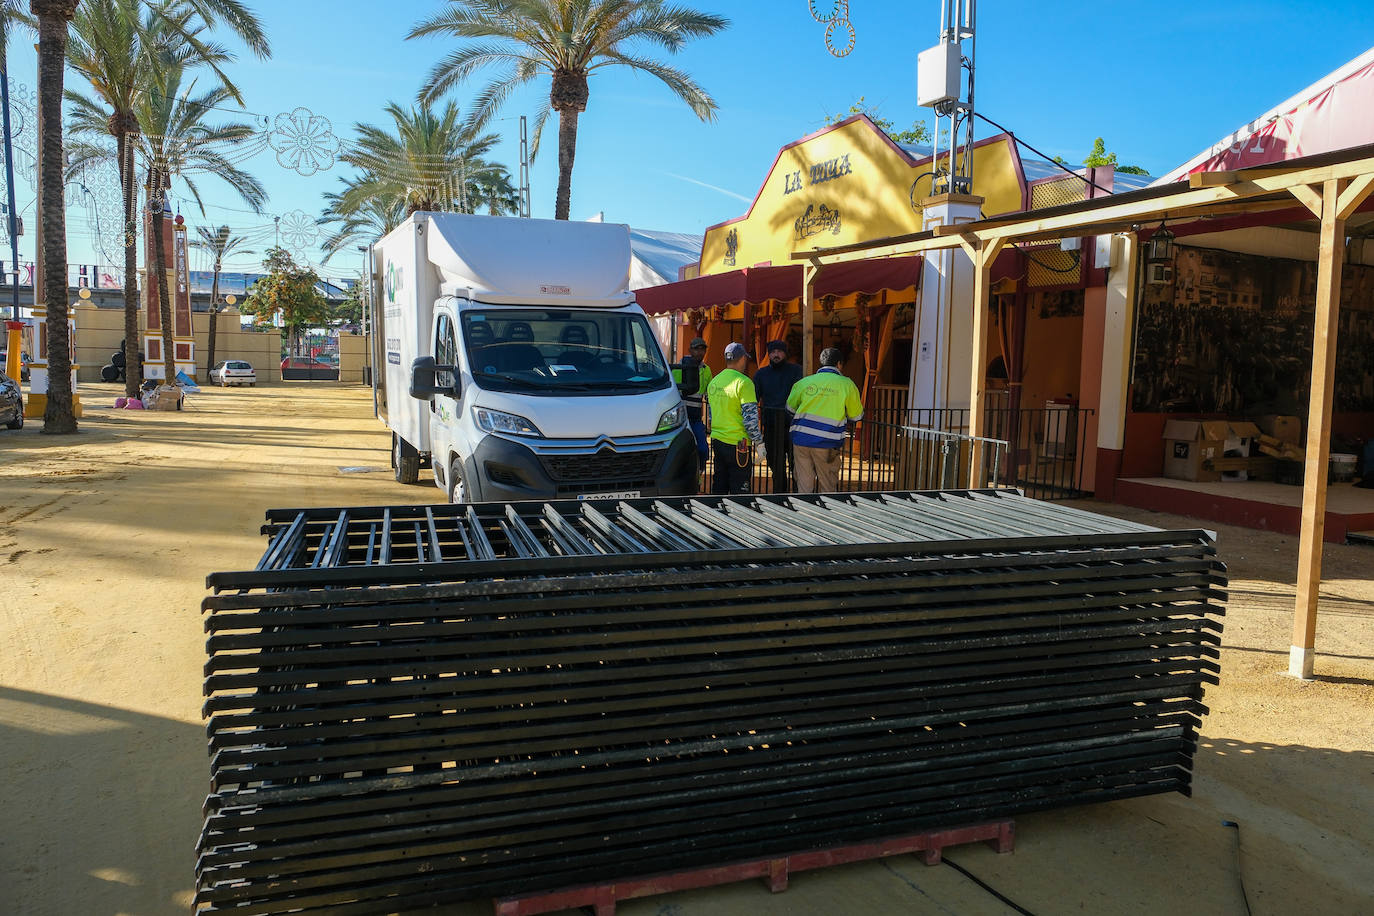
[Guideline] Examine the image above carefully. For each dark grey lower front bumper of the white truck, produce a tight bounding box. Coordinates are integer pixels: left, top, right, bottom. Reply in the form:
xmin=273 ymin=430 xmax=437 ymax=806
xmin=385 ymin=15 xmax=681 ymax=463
xmin=463 ymin=427 xmax=697 ymax=503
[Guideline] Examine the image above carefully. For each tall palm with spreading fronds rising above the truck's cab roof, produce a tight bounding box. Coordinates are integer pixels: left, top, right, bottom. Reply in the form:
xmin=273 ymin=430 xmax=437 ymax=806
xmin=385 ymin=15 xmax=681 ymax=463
xmin=408 ymin=0 xmax=730 ymax=220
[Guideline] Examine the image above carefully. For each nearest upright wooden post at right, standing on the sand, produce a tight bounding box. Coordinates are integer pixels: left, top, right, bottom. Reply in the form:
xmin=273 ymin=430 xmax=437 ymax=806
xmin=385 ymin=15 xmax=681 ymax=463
xmin=1289 ymin=179 xmax=1345 ymax=678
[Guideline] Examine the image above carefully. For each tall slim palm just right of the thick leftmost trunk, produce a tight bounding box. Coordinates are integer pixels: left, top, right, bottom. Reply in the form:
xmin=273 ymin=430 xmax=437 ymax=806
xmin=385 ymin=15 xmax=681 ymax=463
xmin=67 ymin=0 xmax=269 ymax=397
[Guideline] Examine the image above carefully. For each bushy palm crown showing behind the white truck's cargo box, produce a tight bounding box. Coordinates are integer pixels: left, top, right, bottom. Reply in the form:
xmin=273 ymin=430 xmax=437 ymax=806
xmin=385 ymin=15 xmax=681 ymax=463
xmin=338 ymin=102 xmax=497 ymax=216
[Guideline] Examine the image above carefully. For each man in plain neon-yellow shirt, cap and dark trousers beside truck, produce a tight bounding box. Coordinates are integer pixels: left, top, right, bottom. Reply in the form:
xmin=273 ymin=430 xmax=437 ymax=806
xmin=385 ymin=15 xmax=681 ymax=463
xmin=706 ymin=343 xmax=768 ymax=496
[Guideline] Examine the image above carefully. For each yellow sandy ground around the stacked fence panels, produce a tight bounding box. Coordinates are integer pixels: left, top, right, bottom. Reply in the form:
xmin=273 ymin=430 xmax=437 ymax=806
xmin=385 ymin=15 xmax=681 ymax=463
xmin=0 ymin=385 xmax=1374 ymax=916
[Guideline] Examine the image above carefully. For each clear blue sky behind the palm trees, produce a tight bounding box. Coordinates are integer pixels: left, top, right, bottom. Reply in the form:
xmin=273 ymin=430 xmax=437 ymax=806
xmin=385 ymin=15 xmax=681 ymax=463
xmin=7 ymin=0 xmax=1374 ymax=284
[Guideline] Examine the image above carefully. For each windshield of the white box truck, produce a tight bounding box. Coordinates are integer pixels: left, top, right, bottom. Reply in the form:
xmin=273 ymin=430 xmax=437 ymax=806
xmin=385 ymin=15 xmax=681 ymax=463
xmin=462 ymin=309 xmax=672 ymax=394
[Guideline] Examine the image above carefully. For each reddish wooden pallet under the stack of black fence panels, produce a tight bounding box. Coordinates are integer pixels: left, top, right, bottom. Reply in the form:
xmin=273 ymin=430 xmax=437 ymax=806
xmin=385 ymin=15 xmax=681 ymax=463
xmin=492 ymin=820 xmax=1015 ymax=916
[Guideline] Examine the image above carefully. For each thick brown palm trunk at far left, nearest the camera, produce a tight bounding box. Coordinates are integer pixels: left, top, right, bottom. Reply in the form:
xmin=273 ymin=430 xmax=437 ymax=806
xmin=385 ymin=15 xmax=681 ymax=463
xmin=29 ymin=0 xmax=80 ymax=434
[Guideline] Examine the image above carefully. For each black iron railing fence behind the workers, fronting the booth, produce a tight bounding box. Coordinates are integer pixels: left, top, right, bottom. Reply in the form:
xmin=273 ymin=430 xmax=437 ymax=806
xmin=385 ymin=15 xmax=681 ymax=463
xmin=701 ymin=405 xmax=1092 ymax=500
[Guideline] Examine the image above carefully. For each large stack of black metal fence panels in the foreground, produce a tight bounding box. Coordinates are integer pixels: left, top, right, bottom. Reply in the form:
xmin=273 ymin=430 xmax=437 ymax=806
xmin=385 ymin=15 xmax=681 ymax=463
xmin=196 ymin=490 xmax=1226 ymax=913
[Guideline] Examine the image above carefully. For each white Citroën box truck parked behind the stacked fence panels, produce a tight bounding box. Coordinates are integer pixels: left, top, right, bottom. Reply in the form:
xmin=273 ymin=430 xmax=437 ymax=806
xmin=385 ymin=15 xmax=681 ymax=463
xmin=374 ymin=213 xmax=697 ymax=503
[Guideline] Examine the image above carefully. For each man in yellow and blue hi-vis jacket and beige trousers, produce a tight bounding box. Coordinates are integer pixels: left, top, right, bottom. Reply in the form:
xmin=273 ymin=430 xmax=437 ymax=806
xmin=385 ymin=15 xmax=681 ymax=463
xmin=787 ymin=347 xmax=863 ymax=493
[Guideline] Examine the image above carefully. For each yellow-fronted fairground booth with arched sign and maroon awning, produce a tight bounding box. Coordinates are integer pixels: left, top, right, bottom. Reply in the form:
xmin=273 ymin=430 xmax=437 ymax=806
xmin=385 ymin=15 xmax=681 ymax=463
xmin=638 ymin=115 xmax=1150 ymax=496
